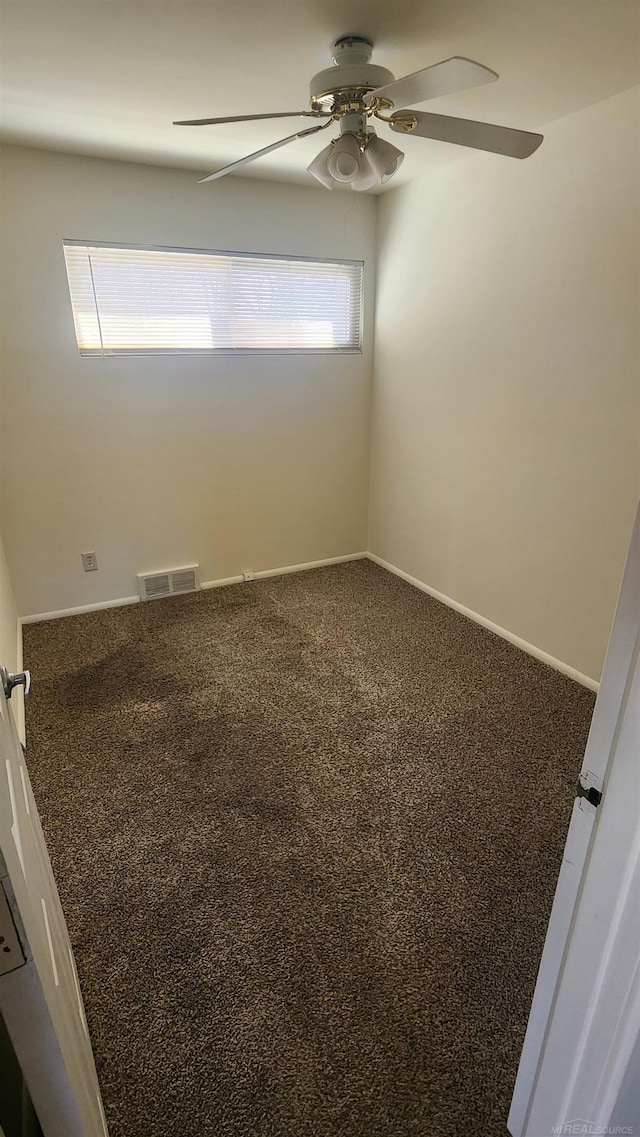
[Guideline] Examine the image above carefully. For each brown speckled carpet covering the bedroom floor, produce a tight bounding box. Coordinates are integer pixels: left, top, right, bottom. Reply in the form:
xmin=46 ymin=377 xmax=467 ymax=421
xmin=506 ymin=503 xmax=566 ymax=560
xmin=24 ymin=561 xmax=593 ymax=1137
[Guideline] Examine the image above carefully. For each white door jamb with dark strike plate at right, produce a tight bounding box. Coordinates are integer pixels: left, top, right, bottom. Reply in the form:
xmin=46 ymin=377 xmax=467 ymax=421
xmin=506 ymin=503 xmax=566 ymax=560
xmin=508 ymin=509 xmax=640 ymax=1137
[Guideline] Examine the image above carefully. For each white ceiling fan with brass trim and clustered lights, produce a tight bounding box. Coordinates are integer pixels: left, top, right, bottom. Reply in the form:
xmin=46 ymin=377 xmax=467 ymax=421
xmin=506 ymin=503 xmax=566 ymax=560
xmin=174 ymin=35 xmax=542 ymax=190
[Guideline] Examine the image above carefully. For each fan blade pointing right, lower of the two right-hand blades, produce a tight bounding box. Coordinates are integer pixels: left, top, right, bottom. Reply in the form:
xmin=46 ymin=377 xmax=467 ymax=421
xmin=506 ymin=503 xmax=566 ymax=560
xmin=389 ymin=110 xmax=543 ymax=158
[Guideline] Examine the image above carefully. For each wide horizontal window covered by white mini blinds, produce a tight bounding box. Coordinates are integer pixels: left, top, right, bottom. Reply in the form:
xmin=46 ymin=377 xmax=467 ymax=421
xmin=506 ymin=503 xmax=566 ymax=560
xmin=64 ymin=241 xmax=363 ymax=356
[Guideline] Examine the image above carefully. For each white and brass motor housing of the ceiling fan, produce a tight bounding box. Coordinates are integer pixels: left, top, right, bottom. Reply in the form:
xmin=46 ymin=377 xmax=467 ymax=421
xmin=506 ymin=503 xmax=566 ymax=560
xmin=309 ymin=36 xmax=394 ymax=111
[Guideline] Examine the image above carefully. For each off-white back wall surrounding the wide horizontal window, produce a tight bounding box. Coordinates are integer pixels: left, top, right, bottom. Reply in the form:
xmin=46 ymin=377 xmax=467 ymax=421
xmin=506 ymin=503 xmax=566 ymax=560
xmin=2 ymin=147 xmax=375 ymax=615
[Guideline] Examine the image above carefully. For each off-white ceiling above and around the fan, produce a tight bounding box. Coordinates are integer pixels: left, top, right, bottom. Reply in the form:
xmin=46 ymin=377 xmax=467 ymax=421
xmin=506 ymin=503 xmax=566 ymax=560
xmin=0 ymin=0 xmax=640 ymax=192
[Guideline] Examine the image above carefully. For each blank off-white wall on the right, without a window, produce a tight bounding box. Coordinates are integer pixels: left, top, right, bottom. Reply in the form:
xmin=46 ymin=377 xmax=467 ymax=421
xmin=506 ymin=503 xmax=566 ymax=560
xmin=369 ymin=91 xmax=640 ymax=679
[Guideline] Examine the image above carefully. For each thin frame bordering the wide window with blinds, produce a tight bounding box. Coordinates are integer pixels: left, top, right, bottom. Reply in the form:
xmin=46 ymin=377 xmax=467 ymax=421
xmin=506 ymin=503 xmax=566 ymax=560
xmin=63 ymin=238 xmax=365 ymax=359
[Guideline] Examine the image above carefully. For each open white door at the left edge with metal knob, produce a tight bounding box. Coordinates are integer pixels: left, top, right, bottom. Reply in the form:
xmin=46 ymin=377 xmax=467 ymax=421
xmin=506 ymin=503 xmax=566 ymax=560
xmin=0 ymin=672 xmax=107 ymax=1137
